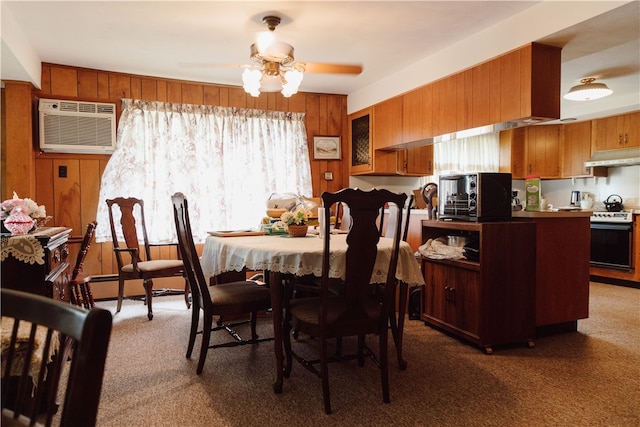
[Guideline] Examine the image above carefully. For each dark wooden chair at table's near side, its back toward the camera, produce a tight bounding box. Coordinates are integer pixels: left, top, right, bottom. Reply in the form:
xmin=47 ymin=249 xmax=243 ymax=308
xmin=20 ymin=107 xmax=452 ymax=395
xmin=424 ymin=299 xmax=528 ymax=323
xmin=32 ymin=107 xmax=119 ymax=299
xmin=283 ymin=188 xmax=407 ymax=414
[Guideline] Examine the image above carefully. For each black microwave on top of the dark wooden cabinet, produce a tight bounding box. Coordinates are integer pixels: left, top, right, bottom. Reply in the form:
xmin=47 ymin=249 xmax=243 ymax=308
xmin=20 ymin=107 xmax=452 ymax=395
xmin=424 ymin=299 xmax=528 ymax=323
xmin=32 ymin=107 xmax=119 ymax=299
xmin=438 ymin=172 xmax=511 ymax=222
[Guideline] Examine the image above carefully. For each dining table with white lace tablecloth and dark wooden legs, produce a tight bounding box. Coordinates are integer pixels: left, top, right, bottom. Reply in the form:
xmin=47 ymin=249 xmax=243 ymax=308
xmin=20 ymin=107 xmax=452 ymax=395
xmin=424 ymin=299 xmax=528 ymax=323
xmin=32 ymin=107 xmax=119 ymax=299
xmin=201 ymin=233 xmax=424 ymax=393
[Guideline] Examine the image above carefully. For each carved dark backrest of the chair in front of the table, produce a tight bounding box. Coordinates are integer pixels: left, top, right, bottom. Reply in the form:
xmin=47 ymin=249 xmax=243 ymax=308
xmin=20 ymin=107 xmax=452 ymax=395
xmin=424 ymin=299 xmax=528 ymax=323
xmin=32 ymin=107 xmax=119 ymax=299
xmin=322 ymin=188 xmax=407 ymax=310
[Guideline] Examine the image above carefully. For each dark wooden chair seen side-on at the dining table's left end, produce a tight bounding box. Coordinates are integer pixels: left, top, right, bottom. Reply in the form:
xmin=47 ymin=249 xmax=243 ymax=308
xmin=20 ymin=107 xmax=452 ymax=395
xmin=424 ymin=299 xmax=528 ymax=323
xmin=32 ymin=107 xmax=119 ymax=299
xmin=171 ymin=193 xmax=273 ymax=374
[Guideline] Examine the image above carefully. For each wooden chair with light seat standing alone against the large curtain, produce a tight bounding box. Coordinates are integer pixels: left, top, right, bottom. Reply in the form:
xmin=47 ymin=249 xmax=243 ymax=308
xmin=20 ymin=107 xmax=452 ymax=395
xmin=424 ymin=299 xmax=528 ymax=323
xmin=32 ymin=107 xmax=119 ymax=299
xmin=106 ymin=197 xmax=191 ymax=320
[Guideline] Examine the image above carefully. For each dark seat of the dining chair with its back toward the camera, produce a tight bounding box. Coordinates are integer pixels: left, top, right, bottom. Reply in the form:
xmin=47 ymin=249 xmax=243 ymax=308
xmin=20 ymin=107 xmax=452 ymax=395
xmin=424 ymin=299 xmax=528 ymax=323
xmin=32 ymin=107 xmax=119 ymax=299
xmin=290 ymin=296 xmax=381 ymax=325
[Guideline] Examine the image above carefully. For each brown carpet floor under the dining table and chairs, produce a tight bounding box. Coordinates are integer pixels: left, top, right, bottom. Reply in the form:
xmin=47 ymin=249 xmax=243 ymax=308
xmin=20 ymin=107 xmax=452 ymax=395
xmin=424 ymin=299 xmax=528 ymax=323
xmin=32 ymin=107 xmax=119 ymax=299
xmin=98 ymin=283 xmax=640 ymax=427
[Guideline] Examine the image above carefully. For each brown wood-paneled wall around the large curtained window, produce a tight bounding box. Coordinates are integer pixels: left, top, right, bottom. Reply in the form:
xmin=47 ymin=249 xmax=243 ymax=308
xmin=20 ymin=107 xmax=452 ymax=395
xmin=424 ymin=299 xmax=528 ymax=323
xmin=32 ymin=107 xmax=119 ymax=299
xmin=2 ymin=63 xmax=349 ymax=288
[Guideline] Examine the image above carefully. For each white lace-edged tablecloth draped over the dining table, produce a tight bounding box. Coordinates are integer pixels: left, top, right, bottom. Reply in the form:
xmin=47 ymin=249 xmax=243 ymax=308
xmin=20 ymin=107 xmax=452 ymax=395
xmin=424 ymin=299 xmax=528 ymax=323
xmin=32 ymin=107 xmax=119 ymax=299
xmin=201 ymin=234 xmax=424 ymax=285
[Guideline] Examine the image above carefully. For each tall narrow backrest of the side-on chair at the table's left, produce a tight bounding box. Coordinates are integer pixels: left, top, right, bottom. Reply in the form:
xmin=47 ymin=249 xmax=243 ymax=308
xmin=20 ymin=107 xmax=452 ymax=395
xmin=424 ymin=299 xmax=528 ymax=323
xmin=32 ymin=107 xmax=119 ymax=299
xmin=171 ymin=193 xmax=211 ymax=310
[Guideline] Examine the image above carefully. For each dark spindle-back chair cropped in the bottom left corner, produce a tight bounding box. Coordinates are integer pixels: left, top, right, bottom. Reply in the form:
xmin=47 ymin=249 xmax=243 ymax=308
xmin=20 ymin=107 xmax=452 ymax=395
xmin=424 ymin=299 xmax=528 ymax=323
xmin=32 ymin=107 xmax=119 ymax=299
xmin=0 ymin=288 xmax=112 ymax=427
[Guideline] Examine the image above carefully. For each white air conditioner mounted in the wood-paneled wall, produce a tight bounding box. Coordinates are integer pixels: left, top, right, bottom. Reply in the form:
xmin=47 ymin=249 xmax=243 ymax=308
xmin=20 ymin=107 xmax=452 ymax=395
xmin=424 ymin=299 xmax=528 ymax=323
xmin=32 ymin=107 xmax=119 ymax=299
xmin=38 ymin=99 xmax=116 ymax=154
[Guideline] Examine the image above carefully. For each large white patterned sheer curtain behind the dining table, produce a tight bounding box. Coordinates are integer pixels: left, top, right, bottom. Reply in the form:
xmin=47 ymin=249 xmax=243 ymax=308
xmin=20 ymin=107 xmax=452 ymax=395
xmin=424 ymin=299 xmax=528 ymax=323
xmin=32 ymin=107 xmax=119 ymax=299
xmin=96 ymin=99 xmax=312 ymax=243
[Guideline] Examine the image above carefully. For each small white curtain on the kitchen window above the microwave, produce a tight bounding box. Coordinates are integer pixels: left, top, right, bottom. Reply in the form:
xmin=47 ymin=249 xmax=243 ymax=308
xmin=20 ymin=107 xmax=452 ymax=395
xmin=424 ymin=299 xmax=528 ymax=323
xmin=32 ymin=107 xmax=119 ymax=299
xmin=433 ymin=132 xmax=500 ymax=176
